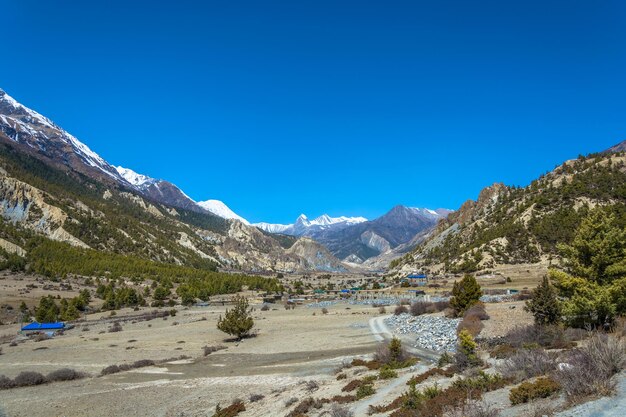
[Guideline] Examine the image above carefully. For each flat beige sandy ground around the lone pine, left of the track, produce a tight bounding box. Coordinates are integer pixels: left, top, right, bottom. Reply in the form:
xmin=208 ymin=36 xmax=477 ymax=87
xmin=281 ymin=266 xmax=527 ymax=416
xmin=0 ymin=305 xmax=378 ymax=416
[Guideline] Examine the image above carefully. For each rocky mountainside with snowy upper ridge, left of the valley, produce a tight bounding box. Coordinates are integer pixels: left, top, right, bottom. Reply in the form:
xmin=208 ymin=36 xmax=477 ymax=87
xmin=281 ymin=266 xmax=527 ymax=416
xmin=0 ymin=90 xmax=345 ymax=272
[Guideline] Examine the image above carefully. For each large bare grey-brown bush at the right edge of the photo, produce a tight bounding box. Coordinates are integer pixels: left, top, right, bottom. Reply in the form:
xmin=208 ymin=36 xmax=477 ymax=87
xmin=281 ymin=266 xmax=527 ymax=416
xmin=554 ymin=333 xmax=626 ymax=401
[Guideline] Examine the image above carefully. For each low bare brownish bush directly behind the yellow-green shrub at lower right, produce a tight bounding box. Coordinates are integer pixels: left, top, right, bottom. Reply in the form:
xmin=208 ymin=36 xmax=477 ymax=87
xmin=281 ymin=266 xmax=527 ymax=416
xmin=498 ymin=349 xmax=557 ymax=382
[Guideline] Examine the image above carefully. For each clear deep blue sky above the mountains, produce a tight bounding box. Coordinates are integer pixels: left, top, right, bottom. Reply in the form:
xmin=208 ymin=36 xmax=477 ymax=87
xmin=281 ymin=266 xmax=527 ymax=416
xmin=0 ymin=0 xmax=626 ymax=222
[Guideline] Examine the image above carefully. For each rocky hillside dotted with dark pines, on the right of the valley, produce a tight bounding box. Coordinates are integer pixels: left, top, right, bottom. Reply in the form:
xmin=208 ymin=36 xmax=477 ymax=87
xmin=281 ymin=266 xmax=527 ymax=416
xmin=390 ymin=142 xmax=626 ymax=275
